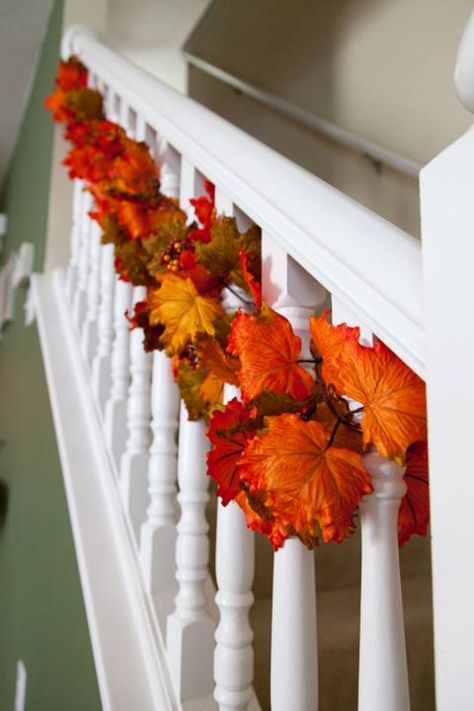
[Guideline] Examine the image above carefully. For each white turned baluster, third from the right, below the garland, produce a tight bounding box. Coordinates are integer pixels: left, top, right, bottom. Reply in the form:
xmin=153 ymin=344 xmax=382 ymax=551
xmin=214 ymin=189 xmax=255 ymax=711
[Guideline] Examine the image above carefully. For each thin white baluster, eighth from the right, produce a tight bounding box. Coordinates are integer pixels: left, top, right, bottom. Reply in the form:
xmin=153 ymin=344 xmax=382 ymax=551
xmin=92 ymin=244 xmax=115 ymax=412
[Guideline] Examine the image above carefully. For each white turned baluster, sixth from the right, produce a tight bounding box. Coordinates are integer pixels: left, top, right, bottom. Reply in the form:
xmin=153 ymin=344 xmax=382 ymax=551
xmin=120 ymin=286 xmax=151 ymax=538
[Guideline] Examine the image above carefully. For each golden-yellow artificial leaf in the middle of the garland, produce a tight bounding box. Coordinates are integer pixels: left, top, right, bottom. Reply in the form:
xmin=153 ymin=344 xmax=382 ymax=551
xmin=148 ymin=273 xmax=222 ymax=355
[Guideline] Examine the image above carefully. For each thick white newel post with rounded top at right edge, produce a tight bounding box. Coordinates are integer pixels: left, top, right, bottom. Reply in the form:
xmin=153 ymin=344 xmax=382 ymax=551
xmin=420 ymin=13 xmax=474 ymax=711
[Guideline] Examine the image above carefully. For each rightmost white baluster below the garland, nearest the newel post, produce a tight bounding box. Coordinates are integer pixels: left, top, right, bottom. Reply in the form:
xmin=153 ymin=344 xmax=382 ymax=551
xmin=358 ymin=453 xmax=410 ymax=711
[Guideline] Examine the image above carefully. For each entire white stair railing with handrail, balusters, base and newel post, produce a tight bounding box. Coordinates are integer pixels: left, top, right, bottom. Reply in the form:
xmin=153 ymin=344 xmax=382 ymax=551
xmin=34 ymin=16 xmax=474 ymax=711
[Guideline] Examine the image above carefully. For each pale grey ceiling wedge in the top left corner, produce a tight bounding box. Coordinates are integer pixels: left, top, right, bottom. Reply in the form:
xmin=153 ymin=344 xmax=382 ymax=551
xmin=0 ymin=0 xmax=52 ymax=192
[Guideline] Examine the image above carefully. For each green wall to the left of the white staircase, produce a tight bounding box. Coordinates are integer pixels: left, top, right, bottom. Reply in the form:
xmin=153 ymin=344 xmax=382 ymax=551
xmin=0 ymin=0 xmax=101 ymax=711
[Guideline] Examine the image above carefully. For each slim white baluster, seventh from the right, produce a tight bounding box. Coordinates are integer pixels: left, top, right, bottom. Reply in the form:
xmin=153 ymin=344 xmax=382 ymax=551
xmin=105 ymin=278 xmax=133 ymax=467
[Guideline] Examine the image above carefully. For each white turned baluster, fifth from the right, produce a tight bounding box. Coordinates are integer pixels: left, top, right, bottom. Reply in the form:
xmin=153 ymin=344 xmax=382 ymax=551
xmin=140 ymin=352 xmax=179 ymax=634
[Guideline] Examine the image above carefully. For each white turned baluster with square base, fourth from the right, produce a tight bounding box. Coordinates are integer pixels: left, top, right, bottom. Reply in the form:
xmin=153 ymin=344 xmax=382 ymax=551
xmin=166 ymin=403 xmax=215 ymax=711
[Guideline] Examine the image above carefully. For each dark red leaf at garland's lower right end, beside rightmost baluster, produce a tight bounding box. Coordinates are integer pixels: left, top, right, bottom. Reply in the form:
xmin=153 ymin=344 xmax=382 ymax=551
xmin=398 ymin=442 xmax=430 ymax=546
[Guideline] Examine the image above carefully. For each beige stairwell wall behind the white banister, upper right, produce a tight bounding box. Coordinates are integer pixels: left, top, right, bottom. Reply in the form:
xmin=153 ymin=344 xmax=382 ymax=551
xmin=187 ymin=0 xmax=473 ymax=236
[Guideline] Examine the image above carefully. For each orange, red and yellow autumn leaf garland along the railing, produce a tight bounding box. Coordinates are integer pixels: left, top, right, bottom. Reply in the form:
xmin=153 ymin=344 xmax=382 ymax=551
xmin=46 ymin=57 xmax=429 ymax=550
